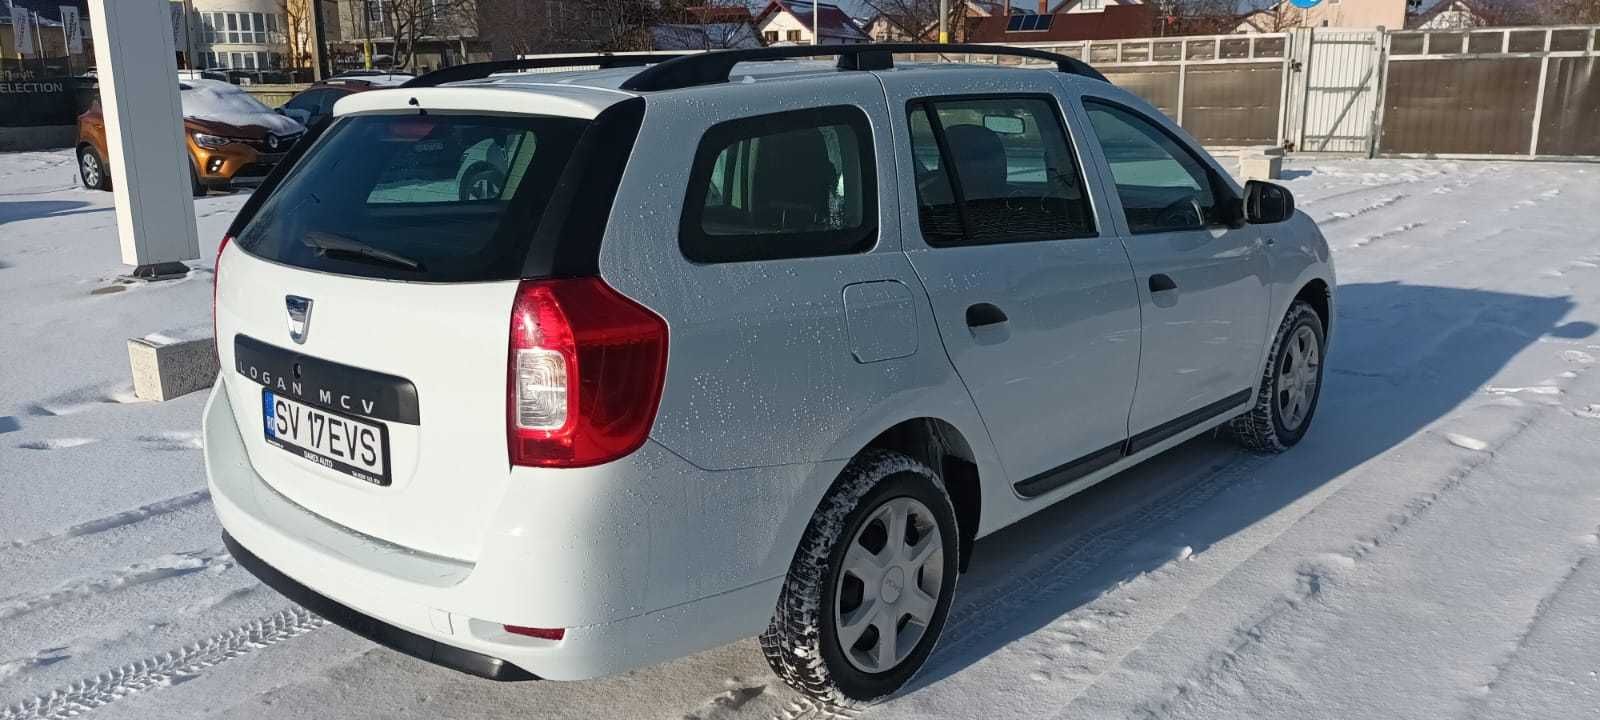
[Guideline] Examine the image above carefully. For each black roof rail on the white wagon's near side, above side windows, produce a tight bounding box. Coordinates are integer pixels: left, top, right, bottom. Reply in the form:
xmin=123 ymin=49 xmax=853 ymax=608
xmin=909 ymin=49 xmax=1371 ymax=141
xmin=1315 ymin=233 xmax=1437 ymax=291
xmin=617 ymin=43 xmax=1106 ymax=91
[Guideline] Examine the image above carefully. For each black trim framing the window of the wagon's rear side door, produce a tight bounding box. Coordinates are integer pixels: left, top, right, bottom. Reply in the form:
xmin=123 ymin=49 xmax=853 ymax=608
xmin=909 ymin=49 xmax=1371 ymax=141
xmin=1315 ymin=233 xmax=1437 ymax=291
xmin=906 ymin=91 xmax=1101 ymax=248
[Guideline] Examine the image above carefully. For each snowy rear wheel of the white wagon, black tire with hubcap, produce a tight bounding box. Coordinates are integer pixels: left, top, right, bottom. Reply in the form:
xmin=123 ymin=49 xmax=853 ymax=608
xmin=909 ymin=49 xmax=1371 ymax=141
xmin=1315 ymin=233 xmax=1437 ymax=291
xmin=762 ymin=450 xmax=960 ymax=707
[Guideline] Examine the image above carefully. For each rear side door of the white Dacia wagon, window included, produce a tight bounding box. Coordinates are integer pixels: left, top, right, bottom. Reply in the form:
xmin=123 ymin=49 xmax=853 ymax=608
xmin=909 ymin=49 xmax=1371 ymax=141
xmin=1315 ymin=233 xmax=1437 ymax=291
xmin=883 ymin=70 xmax=1139 ymax=496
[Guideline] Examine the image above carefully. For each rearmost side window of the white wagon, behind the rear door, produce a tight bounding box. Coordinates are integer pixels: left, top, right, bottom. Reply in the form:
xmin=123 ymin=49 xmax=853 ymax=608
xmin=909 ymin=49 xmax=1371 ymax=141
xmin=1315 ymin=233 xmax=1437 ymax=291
xmin=678 ymin=106 xmax=878 ymax=262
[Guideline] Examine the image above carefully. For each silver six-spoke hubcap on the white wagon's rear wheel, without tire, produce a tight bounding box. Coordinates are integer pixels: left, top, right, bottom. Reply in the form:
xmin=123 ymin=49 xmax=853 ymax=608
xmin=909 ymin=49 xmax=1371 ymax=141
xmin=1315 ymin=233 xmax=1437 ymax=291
xmin=834 ymin=498 xmax=944 ymax=674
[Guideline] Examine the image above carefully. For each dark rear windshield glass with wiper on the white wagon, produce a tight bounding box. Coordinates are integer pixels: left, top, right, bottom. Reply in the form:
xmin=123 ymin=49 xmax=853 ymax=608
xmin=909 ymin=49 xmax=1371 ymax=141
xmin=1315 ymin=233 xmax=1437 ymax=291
xmin=235 ymin=115 xmax=589 ymax=282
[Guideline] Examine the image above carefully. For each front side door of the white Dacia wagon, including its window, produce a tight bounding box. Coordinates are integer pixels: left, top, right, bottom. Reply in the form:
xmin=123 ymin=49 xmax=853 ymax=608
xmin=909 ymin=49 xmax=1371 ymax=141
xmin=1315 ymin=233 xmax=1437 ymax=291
xmin=1083 ymin=94 xmax=1269 ymax=451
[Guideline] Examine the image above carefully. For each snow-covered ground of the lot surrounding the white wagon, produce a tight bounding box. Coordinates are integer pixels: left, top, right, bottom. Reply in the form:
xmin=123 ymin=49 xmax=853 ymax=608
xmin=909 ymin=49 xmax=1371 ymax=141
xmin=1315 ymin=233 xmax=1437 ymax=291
xmin=0 ymin=152 xmax=1600 ymax=720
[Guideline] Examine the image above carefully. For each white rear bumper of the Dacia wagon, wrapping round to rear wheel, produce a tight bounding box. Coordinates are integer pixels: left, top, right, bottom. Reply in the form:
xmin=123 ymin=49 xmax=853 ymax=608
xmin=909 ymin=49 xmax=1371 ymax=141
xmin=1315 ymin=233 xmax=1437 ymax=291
xmin=203 ymin=379 xmax=837 ymax=680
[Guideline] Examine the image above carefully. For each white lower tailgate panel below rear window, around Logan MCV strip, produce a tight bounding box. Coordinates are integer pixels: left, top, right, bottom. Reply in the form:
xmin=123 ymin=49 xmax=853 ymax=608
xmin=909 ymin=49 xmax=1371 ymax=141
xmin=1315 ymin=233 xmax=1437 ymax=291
xmin=216 ymin=246 xmax=517 ymax=560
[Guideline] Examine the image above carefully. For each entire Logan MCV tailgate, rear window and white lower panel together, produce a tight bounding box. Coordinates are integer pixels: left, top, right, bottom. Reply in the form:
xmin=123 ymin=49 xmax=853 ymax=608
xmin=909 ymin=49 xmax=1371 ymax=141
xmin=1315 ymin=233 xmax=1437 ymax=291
xmin=216 ymin=96 xmax=611 ymax=560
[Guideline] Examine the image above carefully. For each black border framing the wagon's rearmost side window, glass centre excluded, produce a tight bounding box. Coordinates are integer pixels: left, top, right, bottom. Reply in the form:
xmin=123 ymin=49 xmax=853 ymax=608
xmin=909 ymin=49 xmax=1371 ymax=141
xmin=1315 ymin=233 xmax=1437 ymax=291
xmin=678 ymin=104 xmax=878 ymax=264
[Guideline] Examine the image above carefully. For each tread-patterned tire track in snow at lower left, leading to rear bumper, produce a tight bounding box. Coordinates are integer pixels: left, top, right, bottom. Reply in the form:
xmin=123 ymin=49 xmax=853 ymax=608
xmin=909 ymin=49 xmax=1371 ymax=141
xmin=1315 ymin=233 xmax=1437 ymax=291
xmin=0 ymin=606 xmax=326 ymax=720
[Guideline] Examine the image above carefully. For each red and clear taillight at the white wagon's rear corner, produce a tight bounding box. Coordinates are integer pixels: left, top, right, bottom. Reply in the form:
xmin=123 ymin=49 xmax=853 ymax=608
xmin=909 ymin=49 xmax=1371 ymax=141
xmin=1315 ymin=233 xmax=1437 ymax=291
xmin=506 ymin=277 xmax=667 ymax=467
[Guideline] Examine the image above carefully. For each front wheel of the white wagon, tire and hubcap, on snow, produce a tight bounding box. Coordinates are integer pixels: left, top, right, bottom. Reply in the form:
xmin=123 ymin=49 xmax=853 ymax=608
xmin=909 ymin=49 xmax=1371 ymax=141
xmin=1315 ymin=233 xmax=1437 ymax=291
xmin=1230 ymin=301 xmax=1326 ymax=453
